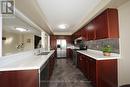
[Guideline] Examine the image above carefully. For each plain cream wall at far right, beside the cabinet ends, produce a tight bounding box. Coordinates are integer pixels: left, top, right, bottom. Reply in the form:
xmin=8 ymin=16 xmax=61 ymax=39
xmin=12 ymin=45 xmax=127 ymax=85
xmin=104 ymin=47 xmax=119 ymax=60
xmin=118 ymin=1 xmax=130 ymax=85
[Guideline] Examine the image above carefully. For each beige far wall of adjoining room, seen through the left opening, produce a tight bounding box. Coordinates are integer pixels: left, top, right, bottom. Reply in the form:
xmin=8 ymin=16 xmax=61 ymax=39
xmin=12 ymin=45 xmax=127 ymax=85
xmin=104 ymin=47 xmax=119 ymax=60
xmin=2 ymin=28 xmax=34 ymax=56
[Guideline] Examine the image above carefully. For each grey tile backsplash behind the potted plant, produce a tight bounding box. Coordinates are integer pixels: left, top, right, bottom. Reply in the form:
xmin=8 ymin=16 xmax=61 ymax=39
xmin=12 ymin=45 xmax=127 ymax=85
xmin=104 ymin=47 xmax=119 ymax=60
xmin=85 ymin=38 xmax=120 ymax=53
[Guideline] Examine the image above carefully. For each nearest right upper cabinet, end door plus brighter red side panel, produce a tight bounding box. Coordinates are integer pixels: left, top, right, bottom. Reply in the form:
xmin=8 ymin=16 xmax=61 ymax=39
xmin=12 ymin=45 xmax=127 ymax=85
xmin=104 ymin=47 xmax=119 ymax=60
xmin=94 ymin=9 xmax=119 ymax=39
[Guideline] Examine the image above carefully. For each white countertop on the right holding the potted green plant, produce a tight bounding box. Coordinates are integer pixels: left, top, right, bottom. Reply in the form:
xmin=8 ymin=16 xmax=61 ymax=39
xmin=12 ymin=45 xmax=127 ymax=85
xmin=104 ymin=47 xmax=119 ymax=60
xmin=77 ymin=49 xmax=120 ymax=60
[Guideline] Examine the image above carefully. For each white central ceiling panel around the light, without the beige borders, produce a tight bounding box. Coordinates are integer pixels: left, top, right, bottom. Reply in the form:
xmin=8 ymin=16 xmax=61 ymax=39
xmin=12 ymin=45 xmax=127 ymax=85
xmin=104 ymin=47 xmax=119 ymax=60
xmin=37 ymin=0 xmax=101 ymax=34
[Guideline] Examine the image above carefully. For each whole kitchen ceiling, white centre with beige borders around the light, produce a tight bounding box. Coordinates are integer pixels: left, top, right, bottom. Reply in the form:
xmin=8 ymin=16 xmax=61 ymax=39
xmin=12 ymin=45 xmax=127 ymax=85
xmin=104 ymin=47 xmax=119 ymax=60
xmin=15 ymin=0 xmax=128 ymax=35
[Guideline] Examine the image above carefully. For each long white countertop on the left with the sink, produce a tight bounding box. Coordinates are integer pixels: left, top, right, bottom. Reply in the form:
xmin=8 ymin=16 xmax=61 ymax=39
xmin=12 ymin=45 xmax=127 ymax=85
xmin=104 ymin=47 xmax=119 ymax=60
xmin=0 ymin=50 xmax=54 ymax=71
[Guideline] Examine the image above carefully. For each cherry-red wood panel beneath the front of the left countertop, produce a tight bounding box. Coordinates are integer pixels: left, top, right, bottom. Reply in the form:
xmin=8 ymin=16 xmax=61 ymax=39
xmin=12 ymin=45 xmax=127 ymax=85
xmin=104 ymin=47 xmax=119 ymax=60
xmin=0 ymin=70 xmax=39 ymax=87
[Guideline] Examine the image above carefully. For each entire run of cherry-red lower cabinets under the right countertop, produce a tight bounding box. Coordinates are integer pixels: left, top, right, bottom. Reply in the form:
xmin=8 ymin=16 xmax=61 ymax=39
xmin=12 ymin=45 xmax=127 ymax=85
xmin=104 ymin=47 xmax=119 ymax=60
xmin=77 ymin=52 xmax=118 ymax=87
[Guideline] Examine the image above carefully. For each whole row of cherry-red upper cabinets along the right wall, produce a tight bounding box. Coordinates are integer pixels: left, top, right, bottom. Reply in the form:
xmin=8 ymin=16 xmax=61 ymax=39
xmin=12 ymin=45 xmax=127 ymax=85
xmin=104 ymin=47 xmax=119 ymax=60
xmin=72 ymin=8 xmax=119 ymax=40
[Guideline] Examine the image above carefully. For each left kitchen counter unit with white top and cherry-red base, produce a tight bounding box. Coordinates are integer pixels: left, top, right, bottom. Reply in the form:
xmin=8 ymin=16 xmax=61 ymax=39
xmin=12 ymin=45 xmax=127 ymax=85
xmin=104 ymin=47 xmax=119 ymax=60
xmin=0 ymin=50 xmax=56 ymax=87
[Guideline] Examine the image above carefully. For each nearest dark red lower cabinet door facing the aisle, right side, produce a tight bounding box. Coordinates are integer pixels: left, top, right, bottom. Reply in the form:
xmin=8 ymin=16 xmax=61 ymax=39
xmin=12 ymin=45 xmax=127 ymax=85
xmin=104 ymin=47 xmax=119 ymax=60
xmin=89 ymin=58 xmax=96 ymax=87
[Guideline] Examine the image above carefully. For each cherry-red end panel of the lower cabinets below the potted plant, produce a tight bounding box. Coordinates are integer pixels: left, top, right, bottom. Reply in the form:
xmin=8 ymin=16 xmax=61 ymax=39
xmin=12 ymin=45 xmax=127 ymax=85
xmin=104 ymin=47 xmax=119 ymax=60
xmin=98 ymin=60 xmax=118 ymax=87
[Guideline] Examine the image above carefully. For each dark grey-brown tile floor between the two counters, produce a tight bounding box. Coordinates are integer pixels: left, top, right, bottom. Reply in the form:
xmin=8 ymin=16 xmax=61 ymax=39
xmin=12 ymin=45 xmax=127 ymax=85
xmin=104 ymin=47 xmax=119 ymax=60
xmin=49 ymin=59 xmax=92 ymax=87
